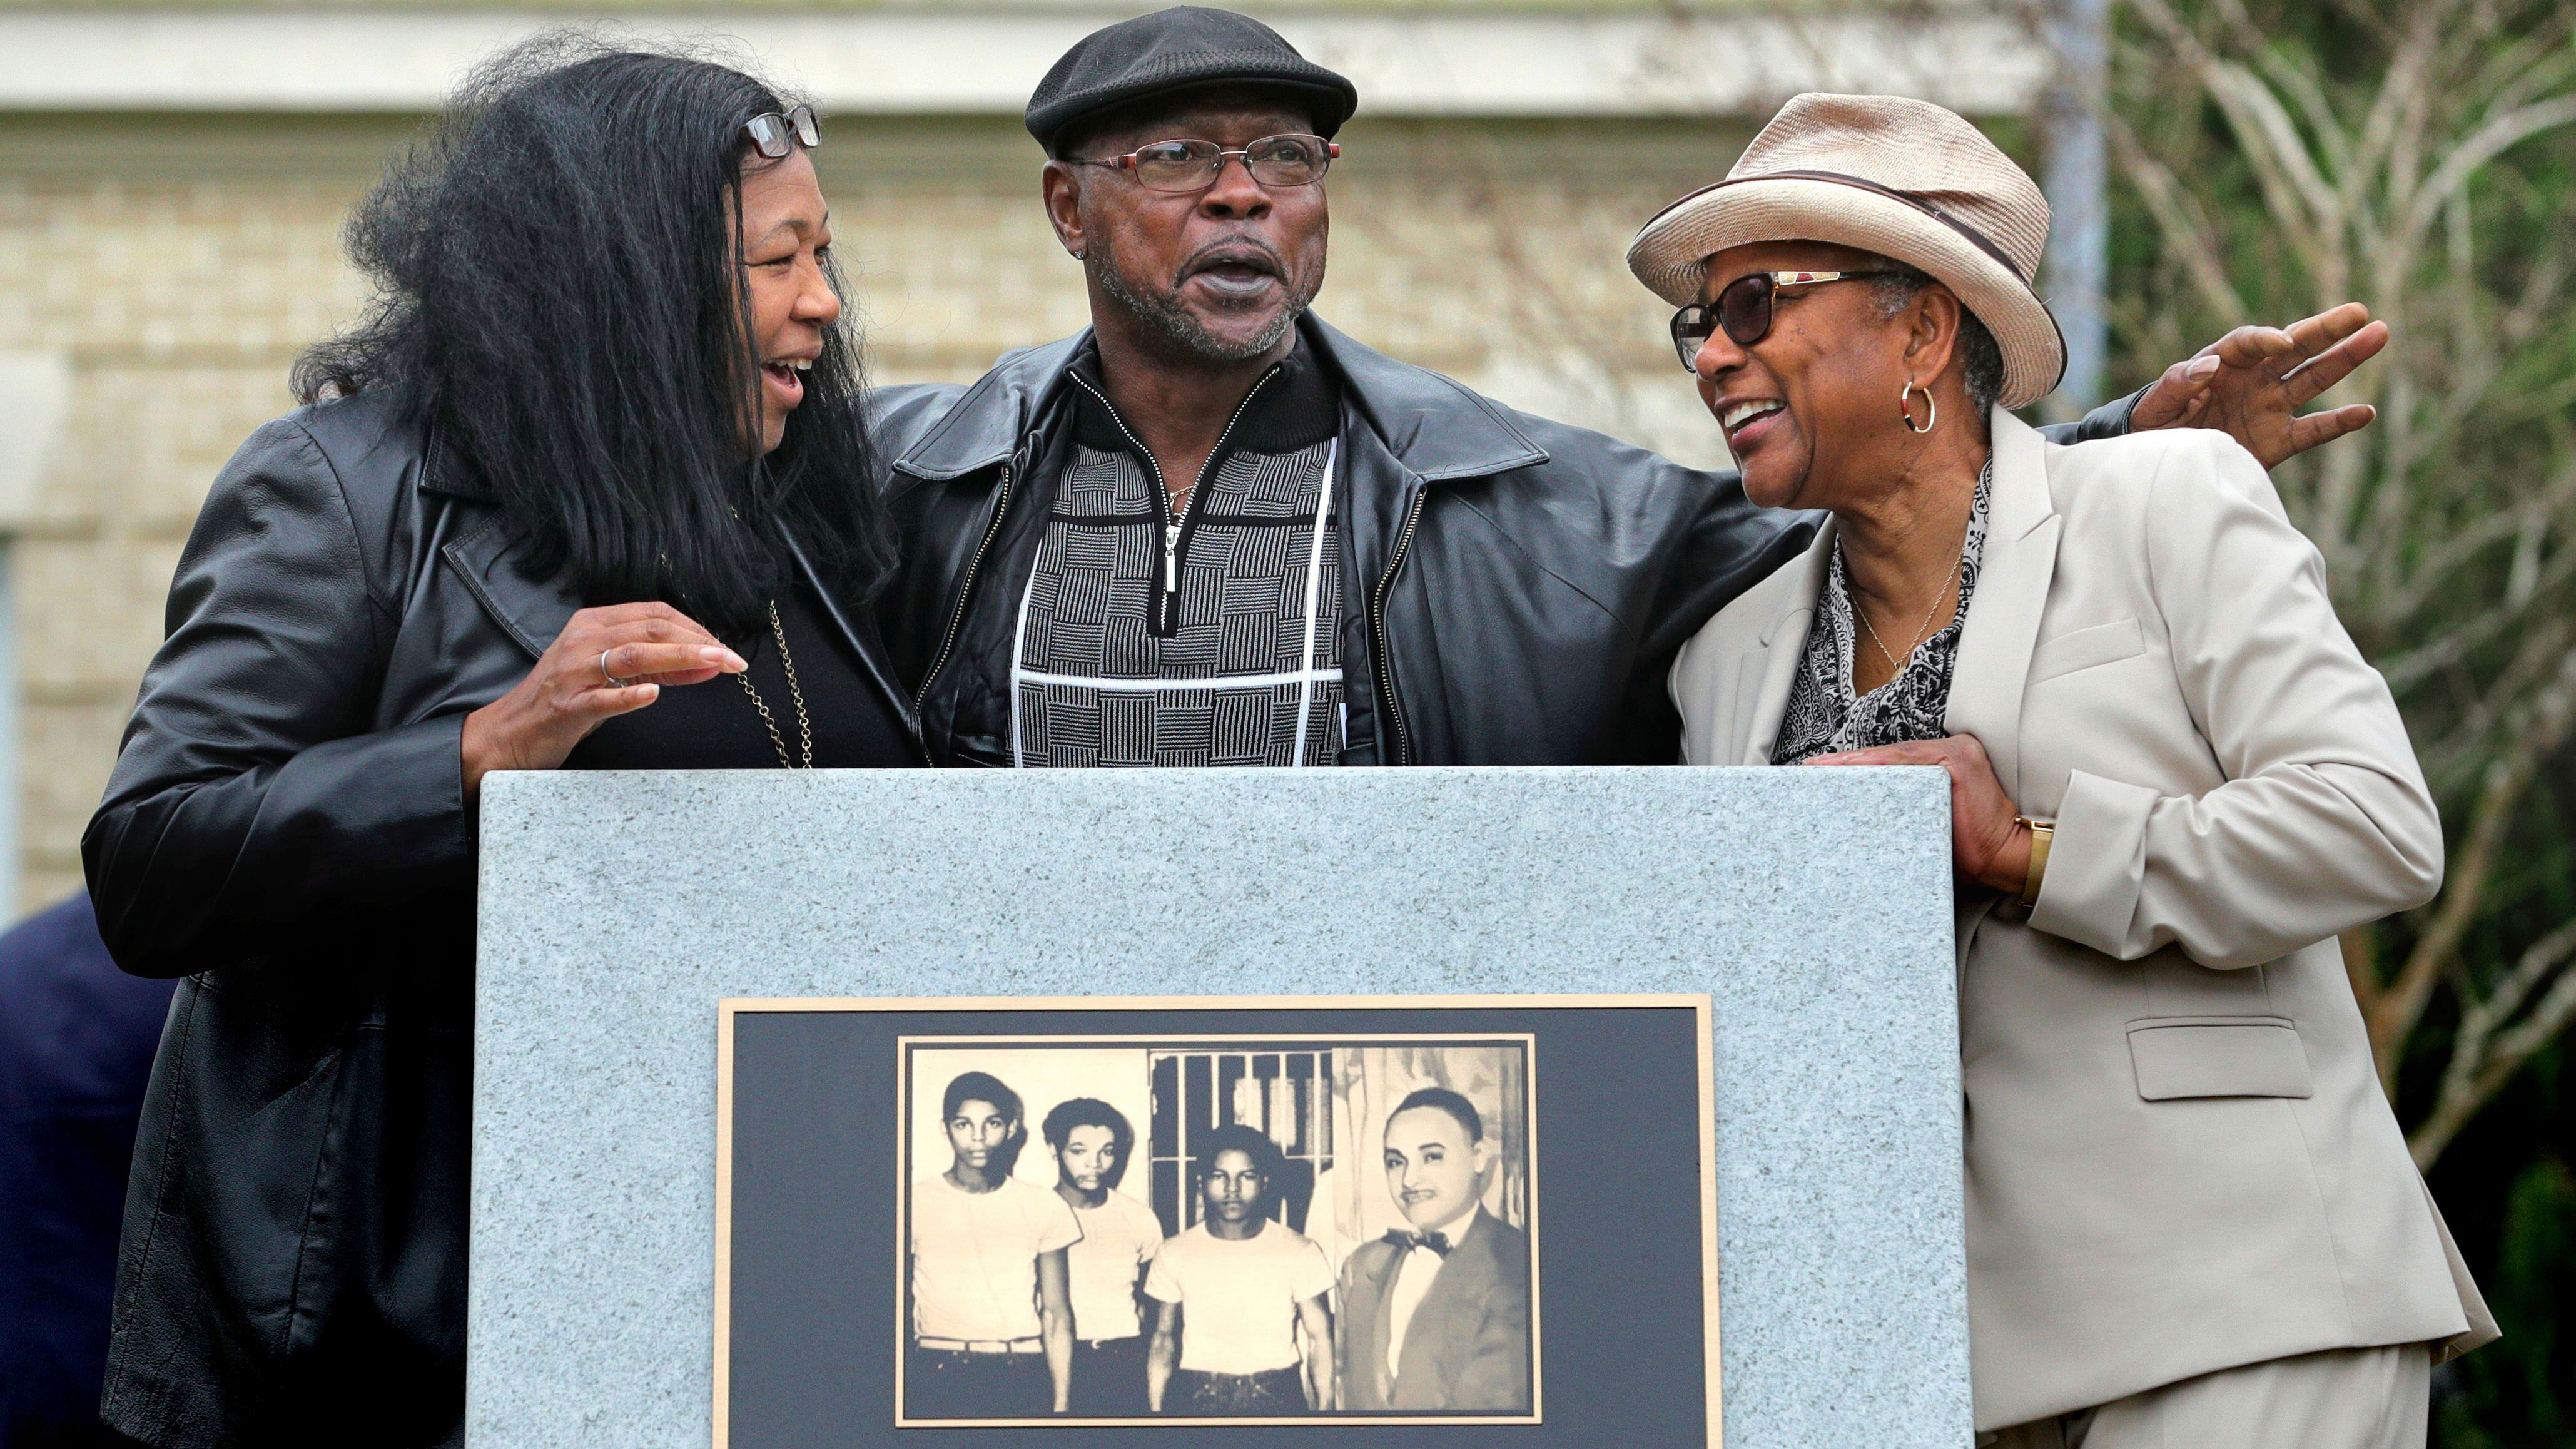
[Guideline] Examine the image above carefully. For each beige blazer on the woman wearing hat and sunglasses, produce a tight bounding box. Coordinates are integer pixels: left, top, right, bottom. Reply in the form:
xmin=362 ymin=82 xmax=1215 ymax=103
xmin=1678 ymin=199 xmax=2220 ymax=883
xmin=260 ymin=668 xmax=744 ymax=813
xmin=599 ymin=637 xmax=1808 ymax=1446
xmin=1672 ymin=412 xmax=2496 ymax=1428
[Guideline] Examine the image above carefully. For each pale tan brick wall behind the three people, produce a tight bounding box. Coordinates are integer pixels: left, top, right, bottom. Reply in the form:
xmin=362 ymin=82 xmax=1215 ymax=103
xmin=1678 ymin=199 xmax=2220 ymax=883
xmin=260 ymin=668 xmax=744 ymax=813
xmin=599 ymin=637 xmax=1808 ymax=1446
xmin=0 ymin=116 xmax=1744 ymax=905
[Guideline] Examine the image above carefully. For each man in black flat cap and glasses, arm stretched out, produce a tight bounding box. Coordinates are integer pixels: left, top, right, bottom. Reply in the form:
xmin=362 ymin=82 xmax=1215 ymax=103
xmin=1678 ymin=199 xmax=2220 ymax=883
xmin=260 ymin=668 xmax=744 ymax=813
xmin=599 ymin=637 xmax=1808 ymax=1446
xmin=873 ymin=5 xmax=2375 ymax=766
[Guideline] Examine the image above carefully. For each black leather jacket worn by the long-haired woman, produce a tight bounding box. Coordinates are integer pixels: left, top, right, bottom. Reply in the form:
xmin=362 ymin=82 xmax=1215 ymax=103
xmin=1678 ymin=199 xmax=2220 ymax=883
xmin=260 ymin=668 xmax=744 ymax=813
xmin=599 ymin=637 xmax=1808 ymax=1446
xmin=83 ymin=395 xmax=910 ymax=1449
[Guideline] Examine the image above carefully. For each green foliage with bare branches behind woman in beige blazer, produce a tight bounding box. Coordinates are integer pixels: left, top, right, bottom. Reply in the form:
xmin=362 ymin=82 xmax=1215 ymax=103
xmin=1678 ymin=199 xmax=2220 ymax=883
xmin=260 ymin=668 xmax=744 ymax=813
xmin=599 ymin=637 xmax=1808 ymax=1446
xmin=2104 ymin=0 xmax=2576 ymax=1449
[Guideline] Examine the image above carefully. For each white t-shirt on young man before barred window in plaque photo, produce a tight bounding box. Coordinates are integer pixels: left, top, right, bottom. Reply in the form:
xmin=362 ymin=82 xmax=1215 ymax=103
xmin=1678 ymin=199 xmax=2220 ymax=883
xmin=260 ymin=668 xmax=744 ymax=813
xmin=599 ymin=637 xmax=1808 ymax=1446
xmin=1143 ymin=1219 xmax=1332 ymax=1374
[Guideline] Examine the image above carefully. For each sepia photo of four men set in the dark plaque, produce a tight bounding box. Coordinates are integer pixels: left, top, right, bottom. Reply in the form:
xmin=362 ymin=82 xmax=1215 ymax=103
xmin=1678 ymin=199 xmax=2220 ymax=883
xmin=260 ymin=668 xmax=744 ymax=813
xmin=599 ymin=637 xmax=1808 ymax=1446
xmin=901 ymin=1042 xmax=1535 ymax=1423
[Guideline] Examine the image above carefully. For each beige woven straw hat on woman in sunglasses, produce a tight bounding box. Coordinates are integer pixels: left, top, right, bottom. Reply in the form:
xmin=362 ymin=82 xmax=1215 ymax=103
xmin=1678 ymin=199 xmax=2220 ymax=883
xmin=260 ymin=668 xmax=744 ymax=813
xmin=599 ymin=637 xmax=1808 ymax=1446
xmin=1628 ymin=93 xmax=2066 ymax=407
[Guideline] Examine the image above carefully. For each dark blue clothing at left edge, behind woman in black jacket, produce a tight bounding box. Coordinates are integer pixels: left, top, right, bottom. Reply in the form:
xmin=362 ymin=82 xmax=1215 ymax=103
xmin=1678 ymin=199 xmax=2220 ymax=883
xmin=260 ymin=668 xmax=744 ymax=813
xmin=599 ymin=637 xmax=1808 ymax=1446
xmin=0 ymin=895 xmax=178 ymax=1446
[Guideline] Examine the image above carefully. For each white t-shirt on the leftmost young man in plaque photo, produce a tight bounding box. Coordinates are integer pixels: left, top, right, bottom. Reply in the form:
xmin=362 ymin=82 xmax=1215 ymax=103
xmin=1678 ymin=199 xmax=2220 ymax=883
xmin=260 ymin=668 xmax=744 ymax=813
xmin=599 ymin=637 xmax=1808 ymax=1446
xmin=912 ymin=1173 xmax=1082 ymax=1341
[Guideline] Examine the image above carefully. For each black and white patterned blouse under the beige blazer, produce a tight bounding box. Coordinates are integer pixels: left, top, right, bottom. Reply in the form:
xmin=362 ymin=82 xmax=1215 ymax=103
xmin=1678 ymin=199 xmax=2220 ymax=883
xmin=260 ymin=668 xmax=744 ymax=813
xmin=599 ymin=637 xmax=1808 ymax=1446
xmin=1772 ymin=459 xmax=1994 ymax=766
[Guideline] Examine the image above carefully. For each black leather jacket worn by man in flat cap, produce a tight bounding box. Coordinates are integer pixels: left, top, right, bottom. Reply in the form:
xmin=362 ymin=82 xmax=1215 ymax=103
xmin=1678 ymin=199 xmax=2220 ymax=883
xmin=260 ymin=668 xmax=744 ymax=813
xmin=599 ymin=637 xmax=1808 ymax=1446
xmin=876 ymin=315 xmax=2133 ymax=766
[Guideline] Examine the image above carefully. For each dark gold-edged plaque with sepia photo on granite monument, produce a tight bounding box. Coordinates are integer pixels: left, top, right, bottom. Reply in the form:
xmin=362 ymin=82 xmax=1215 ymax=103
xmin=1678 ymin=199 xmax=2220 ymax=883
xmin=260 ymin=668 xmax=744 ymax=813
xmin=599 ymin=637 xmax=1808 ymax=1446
xmin=714 ymin=995 xmax=1718 ymax=1449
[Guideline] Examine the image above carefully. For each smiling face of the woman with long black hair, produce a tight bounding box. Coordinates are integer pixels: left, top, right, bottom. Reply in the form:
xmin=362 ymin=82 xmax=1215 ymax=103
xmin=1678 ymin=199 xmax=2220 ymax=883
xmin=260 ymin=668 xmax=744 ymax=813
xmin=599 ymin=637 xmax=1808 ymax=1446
xmin=742 ymin=150 xmax=839 ymax=454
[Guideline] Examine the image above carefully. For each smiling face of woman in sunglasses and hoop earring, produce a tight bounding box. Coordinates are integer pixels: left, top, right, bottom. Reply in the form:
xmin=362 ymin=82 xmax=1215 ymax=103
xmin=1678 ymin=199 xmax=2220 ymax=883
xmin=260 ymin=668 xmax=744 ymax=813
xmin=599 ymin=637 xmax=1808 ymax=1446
xmin=1693 ymin=242 xmax=1906 ymax=508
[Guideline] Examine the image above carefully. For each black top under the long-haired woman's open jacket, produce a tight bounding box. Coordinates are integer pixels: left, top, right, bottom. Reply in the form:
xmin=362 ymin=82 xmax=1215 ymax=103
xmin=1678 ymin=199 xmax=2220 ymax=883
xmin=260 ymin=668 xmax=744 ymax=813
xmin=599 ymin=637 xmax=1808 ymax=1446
xmin=564 ymin=588 xmax=915 ymax=771
